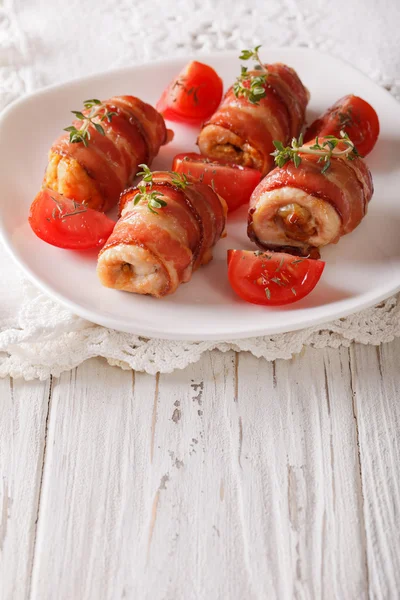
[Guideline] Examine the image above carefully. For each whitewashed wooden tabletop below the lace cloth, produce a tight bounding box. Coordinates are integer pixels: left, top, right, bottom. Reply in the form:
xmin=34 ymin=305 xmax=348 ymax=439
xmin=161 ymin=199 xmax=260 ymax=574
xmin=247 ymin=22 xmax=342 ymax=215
xmin=0 ymin=340 xmax=400 ymax=600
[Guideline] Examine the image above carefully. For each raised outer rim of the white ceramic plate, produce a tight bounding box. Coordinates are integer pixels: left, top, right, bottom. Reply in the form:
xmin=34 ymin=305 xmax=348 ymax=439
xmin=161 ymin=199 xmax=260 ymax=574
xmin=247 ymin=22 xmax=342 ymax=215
xmin=0 ymin=46 xmax=400 ymax=342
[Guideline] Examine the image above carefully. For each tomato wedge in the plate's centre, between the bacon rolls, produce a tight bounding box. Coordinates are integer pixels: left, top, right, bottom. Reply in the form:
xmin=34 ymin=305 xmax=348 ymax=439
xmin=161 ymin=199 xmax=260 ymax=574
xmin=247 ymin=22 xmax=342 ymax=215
xmin=172 ymin=152 xmax=261 ymax=212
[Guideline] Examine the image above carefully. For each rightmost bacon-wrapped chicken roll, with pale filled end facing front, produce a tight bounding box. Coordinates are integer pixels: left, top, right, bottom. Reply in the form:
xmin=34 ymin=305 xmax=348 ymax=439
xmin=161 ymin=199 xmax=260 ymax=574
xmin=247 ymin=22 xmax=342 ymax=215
xmin=248 ymin=140 xmax=373 ymax=258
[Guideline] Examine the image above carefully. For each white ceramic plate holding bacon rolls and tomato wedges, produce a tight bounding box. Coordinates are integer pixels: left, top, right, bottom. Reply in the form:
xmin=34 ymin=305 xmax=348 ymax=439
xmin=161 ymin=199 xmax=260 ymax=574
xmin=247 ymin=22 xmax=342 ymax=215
xmin=0 ymin=48 xmax=400 ymax=340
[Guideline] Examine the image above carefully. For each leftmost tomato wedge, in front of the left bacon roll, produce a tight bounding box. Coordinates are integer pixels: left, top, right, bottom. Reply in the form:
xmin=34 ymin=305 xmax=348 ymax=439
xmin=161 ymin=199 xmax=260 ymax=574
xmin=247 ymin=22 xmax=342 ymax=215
xmin=29 ymin=188 xmax=115 ymax=250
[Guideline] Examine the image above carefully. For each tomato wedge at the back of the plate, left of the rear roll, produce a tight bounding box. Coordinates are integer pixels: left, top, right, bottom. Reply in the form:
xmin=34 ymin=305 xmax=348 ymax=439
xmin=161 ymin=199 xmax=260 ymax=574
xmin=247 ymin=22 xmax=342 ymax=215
xmin=157 ymin=60 xmax=223 ymax=123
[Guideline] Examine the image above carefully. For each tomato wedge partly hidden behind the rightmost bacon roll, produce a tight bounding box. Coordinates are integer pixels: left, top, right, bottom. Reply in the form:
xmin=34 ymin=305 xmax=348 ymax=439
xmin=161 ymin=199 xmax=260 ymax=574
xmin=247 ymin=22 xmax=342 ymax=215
xmin=304 ymin=95 xmax=379 ymax=156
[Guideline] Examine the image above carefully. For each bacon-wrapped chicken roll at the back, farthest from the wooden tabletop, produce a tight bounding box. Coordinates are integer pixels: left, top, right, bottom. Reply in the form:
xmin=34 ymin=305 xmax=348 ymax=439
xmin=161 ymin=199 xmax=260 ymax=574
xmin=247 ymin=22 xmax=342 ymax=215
xmin=197 ymin=63 xmax=309 ymax=175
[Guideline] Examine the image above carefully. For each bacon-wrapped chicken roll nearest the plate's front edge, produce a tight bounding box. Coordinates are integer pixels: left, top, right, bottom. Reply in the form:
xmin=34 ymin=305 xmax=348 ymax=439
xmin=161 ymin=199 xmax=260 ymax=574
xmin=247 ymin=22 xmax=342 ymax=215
xmin=97 ymin=171 xmax=226 ymax=298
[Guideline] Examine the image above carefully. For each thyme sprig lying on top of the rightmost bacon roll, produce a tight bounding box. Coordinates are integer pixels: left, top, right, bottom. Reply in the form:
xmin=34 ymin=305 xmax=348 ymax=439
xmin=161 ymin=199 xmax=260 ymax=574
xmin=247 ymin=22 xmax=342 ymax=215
xmin=271 ymin=131 xmax=360 ymax=173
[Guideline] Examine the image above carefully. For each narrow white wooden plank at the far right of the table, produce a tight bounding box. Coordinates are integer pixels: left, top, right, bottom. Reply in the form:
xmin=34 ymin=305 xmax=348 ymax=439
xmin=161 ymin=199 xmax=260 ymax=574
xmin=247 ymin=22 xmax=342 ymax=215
xmin=351 ymin=339 xmax=400 ymax=598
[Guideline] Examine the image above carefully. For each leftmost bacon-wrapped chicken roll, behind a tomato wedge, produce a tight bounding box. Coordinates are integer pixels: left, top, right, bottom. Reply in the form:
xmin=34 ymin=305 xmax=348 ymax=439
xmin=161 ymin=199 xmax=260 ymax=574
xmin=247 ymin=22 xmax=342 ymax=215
xmin=43 ymin=96 xmax=172 ymax=211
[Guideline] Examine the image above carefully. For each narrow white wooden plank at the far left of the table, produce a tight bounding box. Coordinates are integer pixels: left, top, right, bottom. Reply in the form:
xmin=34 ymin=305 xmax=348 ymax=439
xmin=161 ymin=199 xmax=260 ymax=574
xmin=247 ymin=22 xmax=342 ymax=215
xmin=0 ymin=377 xmax=50 ymax=600
